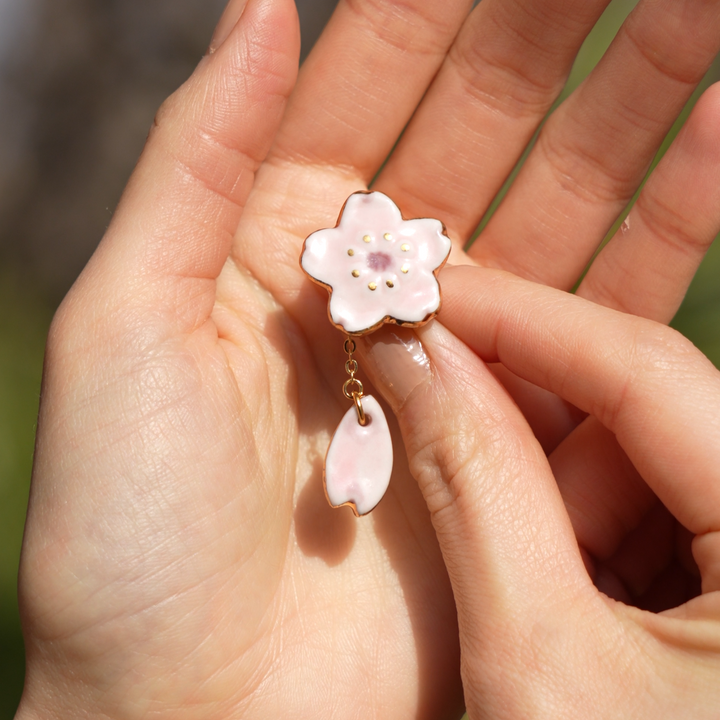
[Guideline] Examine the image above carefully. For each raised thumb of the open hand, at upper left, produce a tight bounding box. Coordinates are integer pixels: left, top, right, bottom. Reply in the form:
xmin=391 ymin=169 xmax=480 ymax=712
xmin=82 ymin=0 xmax=299 ymax=330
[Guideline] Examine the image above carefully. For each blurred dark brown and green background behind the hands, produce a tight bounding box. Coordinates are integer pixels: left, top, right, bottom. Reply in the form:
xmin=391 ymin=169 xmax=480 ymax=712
xmin=0 ymin=0 xmax=720 ymax=719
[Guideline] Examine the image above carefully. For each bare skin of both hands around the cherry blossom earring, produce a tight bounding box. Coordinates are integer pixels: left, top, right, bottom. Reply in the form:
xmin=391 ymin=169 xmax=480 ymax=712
xmin=17 ymin=0 xmax=720 ymax=720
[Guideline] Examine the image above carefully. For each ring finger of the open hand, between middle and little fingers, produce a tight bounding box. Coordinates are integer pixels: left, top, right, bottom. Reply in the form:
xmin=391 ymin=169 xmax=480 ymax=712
xmin=470 ymin=0 xmax=720 ymax=288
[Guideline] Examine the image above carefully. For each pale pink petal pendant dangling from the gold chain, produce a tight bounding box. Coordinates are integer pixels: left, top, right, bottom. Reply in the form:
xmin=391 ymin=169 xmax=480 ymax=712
xmin=325 ymin=395 xmax=393 ymax=515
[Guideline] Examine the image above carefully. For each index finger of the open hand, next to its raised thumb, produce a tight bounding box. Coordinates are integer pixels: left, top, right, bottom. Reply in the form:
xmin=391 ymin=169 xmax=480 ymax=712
xmin=273 ymin=0 xmax=472 ymax=183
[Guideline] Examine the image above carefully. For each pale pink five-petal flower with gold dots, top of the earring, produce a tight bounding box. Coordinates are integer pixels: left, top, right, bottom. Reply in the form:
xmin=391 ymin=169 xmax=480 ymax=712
xmin=301 ymin=192 xmax=451 ymax=333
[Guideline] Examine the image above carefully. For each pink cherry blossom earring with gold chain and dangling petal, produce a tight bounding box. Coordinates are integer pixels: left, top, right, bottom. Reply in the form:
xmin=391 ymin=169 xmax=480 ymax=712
xmin=300 ymin=192 xmax=451 ymax=517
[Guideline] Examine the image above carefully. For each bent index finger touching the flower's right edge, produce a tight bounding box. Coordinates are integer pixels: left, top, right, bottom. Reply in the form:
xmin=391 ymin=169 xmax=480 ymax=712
xmin=442 ymin=267 xmax=720 ymax=591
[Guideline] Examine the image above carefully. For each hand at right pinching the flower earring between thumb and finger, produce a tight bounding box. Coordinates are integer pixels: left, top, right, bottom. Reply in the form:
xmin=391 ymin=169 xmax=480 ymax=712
xmin=358 ymin=268 xmax=720 ymax=720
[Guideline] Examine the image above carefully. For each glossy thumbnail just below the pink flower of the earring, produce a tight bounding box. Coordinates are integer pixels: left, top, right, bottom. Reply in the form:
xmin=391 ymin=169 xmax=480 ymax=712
xmin=360 ymin=326 xmax=432 ymax=410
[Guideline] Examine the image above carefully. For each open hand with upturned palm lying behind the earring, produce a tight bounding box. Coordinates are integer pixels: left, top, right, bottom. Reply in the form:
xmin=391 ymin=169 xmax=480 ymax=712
xmin=19 ymin=0 xmax=720 ymax=719
